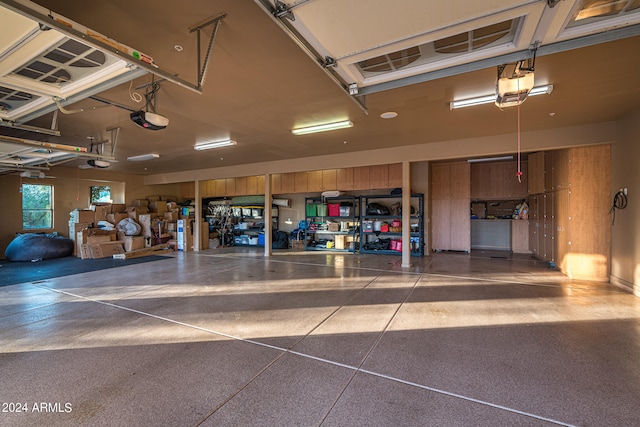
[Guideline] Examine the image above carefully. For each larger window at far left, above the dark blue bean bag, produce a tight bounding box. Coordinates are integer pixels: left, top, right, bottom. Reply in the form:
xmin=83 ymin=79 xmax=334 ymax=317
xmin=22 ymin=184 xmax=53 ymax=230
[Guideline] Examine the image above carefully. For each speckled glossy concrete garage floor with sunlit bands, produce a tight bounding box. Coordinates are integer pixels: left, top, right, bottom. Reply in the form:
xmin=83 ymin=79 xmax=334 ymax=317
xmin=0 ymin=248 xmax=640 ymax=426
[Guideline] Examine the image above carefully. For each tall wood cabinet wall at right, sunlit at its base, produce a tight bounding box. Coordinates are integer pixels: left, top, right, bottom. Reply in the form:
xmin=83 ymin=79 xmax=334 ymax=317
xmin=529 ymin=145 xmax=611 ymax=281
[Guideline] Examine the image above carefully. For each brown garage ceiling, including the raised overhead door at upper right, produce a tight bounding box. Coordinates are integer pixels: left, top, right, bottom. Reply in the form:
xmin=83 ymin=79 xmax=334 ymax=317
xmin=0 ymin=0 xmax=640 ymax=174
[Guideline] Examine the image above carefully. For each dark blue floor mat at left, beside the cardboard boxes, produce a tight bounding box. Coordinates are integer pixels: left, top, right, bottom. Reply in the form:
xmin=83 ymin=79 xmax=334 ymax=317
xmin=0 ymin=255 xmax=169 ymax=287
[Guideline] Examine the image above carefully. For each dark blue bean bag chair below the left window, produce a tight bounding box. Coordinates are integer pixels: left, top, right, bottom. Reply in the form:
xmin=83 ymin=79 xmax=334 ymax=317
xmin=4 ymin=233 xmax=73 ymax=261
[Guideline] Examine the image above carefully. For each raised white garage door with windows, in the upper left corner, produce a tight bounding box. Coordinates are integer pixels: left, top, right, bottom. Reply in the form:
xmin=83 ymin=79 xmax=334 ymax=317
xmin=0 ymin=4 xmax=146 ymax=122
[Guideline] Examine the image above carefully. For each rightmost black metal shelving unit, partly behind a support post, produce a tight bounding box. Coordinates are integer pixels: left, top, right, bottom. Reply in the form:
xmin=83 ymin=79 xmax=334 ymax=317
xmin=360 ymin=193 xmax=424 ymax=256
